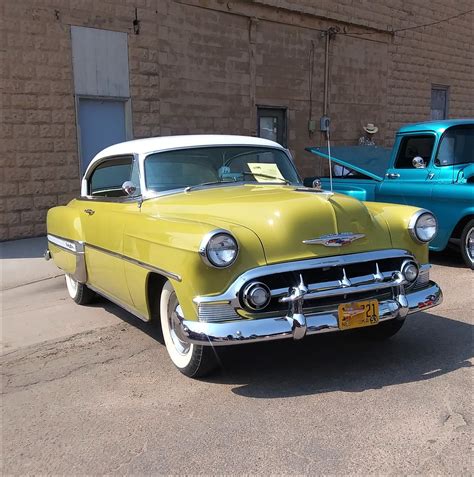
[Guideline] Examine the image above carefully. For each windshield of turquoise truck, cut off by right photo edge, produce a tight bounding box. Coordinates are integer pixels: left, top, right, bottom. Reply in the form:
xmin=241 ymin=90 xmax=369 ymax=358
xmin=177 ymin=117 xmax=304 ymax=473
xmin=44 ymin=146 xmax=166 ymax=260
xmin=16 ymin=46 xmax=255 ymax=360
xmin=435 ymin=125 xmax=474 ymax=166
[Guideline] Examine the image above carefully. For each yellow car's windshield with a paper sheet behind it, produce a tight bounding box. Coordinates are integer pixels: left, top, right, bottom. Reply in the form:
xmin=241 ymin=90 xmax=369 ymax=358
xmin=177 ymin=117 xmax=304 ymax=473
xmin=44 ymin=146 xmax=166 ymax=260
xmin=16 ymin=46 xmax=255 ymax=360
xmin=145 ymin=146 xmax=301 ymax=192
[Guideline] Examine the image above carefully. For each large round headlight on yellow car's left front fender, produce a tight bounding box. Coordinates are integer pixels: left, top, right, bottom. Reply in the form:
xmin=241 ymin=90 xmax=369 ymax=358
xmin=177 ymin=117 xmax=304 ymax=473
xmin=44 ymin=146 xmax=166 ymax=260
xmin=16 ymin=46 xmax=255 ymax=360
xmin=199 ymin=230 xmax=239 ymax=268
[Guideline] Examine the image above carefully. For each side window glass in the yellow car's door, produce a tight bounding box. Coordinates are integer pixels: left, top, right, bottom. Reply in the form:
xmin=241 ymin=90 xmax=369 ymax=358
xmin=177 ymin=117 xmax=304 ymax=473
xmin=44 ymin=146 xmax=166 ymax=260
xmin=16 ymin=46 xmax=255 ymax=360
xmin=89 ymin=157 xmax=139 ymax=197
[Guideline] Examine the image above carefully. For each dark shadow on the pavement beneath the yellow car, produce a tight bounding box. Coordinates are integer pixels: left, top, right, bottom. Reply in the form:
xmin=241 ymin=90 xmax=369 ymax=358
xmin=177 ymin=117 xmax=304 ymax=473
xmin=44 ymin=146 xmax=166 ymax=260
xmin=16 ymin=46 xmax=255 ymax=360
xmin=95 ymin=299 xmax=473 ymax=398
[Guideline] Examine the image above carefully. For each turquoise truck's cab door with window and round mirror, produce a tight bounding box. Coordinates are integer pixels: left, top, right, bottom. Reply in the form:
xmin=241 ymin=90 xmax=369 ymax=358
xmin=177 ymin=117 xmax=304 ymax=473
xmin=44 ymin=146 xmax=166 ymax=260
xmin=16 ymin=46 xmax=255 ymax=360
xmin=376 ymin=133 xmax=436 ymax=209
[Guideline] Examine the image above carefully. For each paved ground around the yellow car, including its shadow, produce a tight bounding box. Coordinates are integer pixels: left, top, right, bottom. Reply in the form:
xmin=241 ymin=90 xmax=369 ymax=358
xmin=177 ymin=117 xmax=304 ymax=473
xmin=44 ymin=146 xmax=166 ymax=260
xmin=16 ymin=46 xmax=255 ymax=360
xmin=1 ymin=239 xmax=474 ymax=475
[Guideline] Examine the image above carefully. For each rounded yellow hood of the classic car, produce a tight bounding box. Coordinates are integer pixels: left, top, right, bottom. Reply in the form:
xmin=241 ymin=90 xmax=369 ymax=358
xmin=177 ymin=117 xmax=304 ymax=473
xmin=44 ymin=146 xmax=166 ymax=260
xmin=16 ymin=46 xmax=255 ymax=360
xmin=143 ymin=185 xmax=391 ymax=263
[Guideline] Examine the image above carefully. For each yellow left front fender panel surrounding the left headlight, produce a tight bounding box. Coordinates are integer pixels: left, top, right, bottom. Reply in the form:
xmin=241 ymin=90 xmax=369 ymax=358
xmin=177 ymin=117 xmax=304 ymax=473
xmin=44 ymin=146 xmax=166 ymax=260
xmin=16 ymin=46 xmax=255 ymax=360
xmin=124 ymin=216 xmax=266 ymax=320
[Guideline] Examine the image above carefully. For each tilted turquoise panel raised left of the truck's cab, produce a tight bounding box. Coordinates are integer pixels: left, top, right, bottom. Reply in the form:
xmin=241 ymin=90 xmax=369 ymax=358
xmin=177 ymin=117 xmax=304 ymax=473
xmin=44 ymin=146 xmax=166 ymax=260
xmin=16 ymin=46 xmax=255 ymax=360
xmin=306 ymin=146 xmax=392 ymax=181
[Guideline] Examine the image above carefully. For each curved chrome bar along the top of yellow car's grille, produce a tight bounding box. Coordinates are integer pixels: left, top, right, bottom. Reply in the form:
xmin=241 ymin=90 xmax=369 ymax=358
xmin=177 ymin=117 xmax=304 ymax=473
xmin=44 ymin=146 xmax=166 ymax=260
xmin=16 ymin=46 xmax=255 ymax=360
xmin=193 ymin=249 xmax=413 ymax=304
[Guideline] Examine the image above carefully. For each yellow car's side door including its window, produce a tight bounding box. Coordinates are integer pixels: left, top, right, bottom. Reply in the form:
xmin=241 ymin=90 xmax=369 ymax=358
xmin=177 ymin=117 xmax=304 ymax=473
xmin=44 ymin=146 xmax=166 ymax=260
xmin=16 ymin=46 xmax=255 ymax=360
xmin=80 ymin=156 xmax=141 ymax=305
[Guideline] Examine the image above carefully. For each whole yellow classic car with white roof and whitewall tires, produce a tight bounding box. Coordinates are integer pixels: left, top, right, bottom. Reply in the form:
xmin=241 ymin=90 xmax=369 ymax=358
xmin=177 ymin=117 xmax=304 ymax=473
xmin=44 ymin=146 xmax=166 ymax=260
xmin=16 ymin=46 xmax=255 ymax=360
xmin=45 ymin=135 xmax=442 ymax=377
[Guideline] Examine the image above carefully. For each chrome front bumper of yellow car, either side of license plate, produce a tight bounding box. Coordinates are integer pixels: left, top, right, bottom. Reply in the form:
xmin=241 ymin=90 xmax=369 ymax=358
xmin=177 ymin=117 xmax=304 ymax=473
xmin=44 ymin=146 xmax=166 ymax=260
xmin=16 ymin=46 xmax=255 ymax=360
xmin=179 ymin=281 xmax=443 ymax=346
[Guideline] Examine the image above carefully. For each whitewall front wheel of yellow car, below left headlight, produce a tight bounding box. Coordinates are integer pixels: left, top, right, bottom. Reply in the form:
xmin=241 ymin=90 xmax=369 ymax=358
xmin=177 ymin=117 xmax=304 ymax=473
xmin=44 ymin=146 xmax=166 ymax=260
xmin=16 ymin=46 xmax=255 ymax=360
xmin=160 ymin=281 xmax=217 ymax=378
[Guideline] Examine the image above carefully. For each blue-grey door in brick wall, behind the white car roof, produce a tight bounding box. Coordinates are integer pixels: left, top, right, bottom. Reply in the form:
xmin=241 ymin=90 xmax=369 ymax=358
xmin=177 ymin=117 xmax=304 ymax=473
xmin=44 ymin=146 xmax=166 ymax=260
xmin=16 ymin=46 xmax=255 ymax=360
xmin=78 ymin=98 xmax=126 ymax=175
